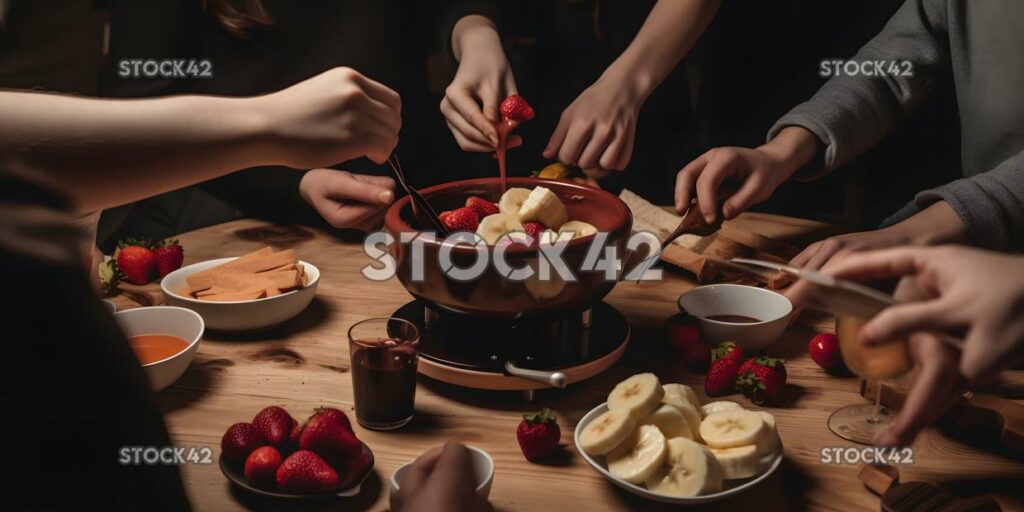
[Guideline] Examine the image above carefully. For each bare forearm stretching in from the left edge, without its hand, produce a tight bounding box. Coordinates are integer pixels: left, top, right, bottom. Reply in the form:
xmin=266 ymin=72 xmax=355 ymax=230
xmin=0 ymin=92 xmax=275 ymax=211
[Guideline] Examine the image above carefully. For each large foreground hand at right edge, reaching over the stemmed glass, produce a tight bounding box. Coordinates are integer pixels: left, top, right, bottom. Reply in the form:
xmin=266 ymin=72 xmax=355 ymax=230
xmin=825 ymin=246 xmax=1024 ymax=384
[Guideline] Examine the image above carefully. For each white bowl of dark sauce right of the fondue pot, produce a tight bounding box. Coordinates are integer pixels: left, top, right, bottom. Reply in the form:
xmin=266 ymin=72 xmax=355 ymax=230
xmin=679 ymin=285 xmax=793 ymax=350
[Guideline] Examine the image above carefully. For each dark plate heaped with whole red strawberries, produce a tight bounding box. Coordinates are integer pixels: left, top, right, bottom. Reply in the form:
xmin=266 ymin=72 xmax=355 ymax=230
xmin=220 ymin=406 xmax=374 ymax=499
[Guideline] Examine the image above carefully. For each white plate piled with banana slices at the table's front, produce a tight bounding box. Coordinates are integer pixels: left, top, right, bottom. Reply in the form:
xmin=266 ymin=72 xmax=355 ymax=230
xmin=572 ymin=373 xmax=782 ymax=504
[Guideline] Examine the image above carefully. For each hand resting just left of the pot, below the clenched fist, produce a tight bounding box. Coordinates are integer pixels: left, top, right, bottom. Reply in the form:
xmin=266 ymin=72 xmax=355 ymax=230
xmin=299 ymin=169 xmax=394 ymax=231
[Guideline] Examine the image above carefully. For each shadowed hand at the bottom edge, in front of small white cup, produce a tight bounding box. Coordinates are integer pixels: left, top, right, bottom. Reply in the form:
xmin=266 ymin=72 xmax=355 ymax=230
xmin=391 ymin=441 xmax=494 ymax=512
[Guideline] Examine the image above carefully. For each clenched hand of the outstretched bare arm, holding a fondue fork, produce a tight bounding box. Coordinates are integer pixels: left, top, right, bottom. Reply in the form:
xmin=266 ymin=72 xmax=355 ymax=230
xmin=260 ymin=68 xmax=401 ymax=169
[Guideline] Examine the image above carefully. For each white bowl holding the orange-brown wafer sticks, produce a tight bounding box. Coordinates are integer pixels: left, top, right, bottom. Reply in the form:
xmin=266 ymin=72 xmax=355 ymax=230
xmin=160 ymin=258 xmax=319 ymax=331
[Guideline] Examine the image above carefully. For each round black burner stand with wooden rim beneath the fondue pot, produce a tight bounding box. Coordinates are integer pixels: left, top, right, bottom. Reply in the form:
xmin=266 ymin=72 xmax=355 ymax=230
xmin=394 ymin=300 xmax=630 ymax=399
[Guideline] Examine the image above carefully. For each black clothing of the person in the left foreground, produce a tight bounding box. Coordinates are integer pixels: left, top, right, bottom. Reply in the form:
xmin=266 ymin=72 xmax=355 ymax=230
xmin=0 ymin=166 xmax=189 ymax=511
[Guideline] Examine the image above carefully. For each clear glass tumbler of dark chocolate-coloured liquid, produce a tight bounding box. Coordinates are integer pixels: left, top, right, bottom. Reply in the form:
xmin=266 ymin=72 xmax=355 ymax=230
xmin=348 ymin=318 xmax=420 ymax=430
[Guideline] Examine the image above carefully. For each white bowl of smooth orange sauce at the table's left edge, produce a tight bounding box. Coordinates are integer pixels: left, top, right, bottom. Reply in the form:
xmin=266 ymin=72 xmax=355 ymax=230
xmin=114 ymin=306 xmax=204 ymax=391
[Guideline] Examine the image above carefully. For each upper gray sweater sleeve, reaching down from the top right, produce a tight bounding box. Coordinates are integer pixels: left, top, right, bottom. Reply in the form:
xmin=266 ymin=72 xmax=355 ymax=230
xmin=768 ymin=0 xmax=949 ymax=179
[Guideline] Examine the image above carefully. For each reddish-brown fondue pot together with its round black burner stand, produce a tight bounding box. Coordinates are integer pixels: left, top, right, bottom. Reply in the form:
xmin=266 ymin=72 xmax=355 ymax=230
xmin=385 ymin=178 xmax=633 ymax=396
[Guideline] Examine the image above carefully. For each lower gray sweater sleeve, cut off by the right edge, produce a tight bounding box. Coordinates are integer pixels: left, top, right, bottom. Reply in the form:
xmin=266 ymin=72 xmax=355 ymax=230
xmin=914 ymin=152 xmax=1024 ymax=251
